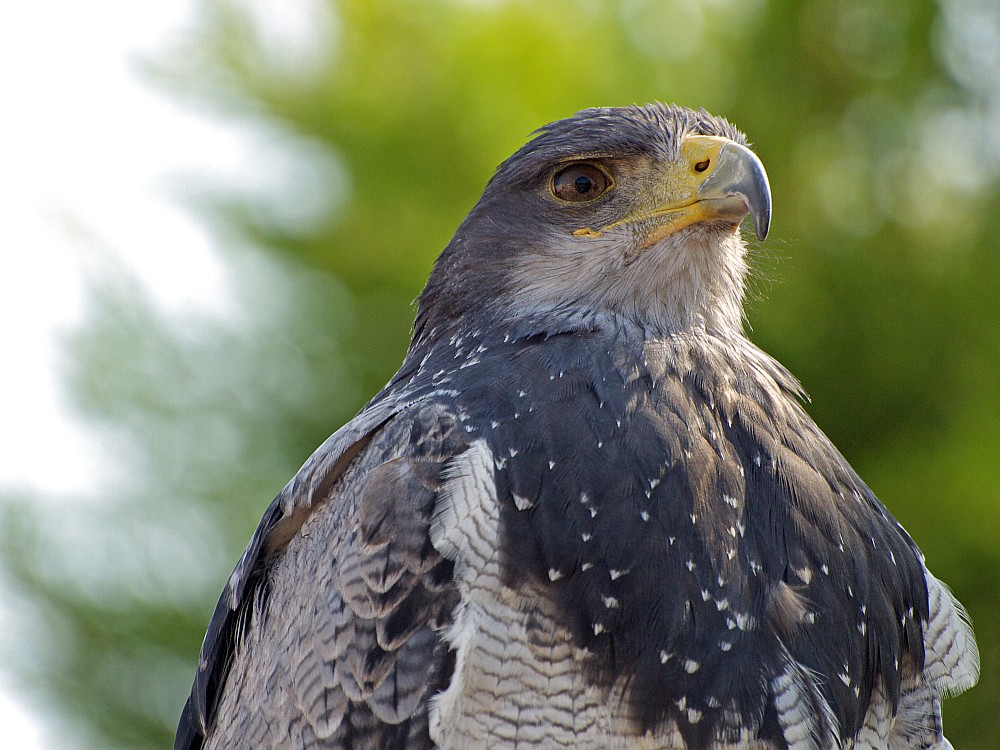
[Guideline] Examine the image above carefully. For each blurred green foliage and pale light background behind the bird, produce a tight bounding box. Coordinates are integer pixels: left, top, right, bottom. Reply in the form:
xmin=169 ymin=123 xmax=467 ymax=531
xmin=0 ymin=0 xmax=1000 ymax=750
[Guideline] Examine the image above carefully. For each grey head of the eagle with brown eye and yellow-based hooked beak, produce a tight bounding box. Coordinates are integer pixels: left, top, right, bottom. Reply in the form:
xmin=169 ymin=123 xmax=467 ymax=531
xmin=416 ymin=104 xmax=771 ymax=339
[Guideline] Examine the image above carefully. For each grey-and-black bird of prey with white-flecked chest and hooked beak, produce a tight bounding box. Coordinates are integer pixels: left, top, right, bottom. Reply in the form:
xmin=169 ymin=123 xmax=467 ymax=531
xmin=175 ymin=104 xmax=978 ymax=750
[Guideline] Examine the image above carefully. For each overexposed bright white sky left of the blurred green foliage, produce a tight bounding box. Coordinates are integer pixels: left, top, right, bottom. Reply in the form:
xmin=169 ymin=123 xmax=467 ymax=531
xmin=0 ymin=0 xmax=247 ymax=750
